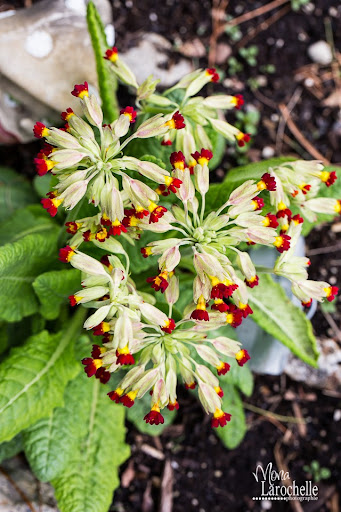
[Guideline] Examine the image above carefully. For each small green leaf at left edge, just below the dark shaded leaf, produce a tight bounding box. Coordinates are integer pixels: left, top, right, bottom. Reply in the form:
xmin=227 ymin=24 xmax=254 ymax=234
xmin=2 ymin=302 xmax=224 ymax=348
xmin=0 ymin=205 xmax=56 ymax=245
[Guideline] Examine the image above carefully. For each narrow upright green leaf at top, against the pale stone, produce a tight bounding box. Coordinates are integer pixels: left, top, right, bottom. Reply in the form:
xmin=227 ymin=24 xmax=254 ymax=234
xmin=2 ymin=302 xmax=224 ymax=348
xmin=86 ymin=2 xmax=118 ymax=123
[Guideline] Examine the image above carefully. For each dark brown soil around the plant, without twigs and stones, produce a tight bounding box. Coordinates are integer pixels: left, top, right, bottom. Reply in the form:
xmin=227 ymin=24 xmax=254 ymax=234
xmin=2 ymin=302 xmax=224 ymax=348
xmin=0 ymin=0 xmax=341 ymax=512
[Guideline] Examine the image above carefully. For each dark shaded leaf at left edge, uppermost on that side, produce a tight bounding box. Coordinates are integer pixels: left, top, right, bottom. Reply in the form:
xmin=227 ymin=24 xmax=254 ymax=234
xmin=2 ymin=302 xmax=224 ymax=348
xmin=0 ymin=167 xmax=37 ymax=222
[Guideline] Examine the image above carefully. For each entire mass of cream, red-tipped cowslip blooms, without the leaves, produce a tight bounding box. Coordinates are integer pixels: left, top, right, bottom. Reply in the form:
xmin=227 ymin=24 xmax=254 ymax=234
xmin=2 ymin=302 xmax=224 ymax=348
xmin=34 ymin=43 xmax=341 ymax=427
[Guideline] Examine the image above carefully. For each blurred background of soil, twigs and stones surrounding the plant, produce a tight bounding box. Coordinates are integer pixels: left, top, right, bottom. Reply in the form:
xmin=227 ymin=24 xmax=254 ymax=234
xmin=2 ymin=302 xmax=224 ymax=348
xmin=0 ymin=0 xmax=341 ymax=512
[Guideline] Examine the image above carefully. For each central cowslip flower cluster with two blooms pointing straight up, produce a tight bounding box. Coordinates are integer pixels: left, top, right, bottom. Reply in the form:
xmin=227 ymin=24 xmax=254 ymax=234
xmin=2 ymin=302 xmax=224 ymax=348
xmin=140 ymin=149 xmax=290 ymax=327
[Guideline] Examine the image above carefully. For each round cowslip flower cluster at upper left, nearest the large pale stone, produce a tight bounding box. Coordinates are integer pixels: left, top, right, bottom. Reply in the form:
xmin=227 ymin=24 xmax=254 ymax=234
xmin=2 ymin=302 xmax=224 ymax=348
xmin=34 ymin=82 xmax=185 ymax=242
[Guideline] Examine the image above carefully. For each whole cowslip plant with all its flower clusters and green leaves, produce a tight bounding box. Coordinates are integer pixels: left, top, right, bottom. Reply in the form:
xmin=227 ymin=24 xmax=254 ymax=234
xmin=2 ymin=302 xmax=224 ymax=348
xmin=0 ymin=2 xmax=341 ymax=512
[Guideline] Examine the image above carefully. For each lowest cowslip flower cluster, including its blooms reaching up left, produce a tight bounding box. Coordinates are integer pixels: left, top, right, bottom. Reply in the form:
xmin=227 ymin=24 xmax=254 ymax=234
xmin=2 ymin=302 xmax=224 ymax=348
xmin=60 ymin=246 xmax=250 ymax=427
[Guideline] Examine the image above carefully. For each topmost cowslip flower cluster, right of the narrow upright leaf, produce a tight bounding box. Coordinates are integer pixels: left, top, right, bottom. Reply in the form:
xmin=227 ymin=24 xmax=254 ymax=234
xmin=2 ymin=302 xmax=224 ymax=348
xmin=105 ymin=47 xmax=250 ymax=160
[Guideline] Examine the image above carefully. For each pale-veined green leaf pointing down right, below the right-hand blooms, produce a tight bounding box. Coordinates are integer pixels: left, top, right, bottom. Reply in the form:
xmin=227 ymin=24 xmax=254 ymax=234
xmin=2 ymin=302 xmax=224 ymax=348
xmin=249 ymin=274 xmax=319 ymax=367
